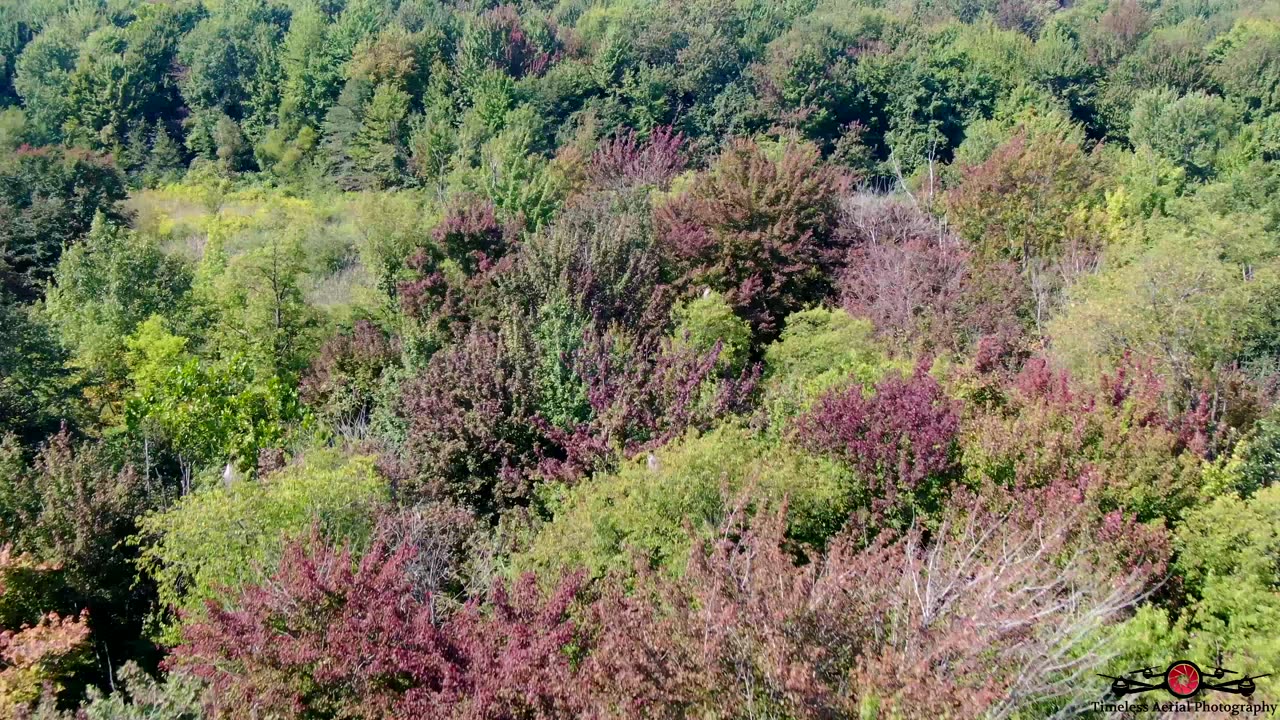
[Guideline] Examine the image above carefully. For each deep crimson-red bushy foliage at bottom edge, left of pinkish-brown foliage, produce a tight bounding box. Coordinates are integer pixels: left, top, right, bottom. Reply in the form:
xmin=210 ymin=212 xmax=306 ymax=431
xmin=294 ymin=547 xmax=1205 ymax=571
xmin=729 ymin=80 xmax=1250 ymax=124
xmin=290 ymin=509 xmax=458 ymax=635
xmin=173 ymin=527 xmax=580 ymax=720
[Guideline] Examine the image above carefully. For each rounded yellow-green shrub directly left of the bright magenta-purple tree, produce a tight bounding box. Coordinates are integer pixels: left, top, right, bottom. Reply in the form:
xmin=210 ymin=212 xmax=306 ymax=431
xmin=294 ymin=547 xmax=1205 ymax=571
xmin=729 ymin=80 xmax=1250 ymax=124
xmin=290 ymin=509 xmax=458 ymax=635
xmin=513 ymin=425 xmax=856 ymax=575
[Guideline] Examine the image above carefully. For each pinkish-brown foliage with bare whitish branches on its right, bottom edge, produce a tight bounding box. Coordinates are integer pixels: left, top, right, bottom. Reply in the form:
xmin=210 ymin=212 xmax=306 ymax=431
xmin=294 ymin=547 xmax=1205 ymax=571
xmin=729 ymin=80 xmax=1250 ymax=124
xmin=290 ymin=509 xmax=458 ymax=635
xmin=585 ymin=479 xmax=1153 ymax=719
